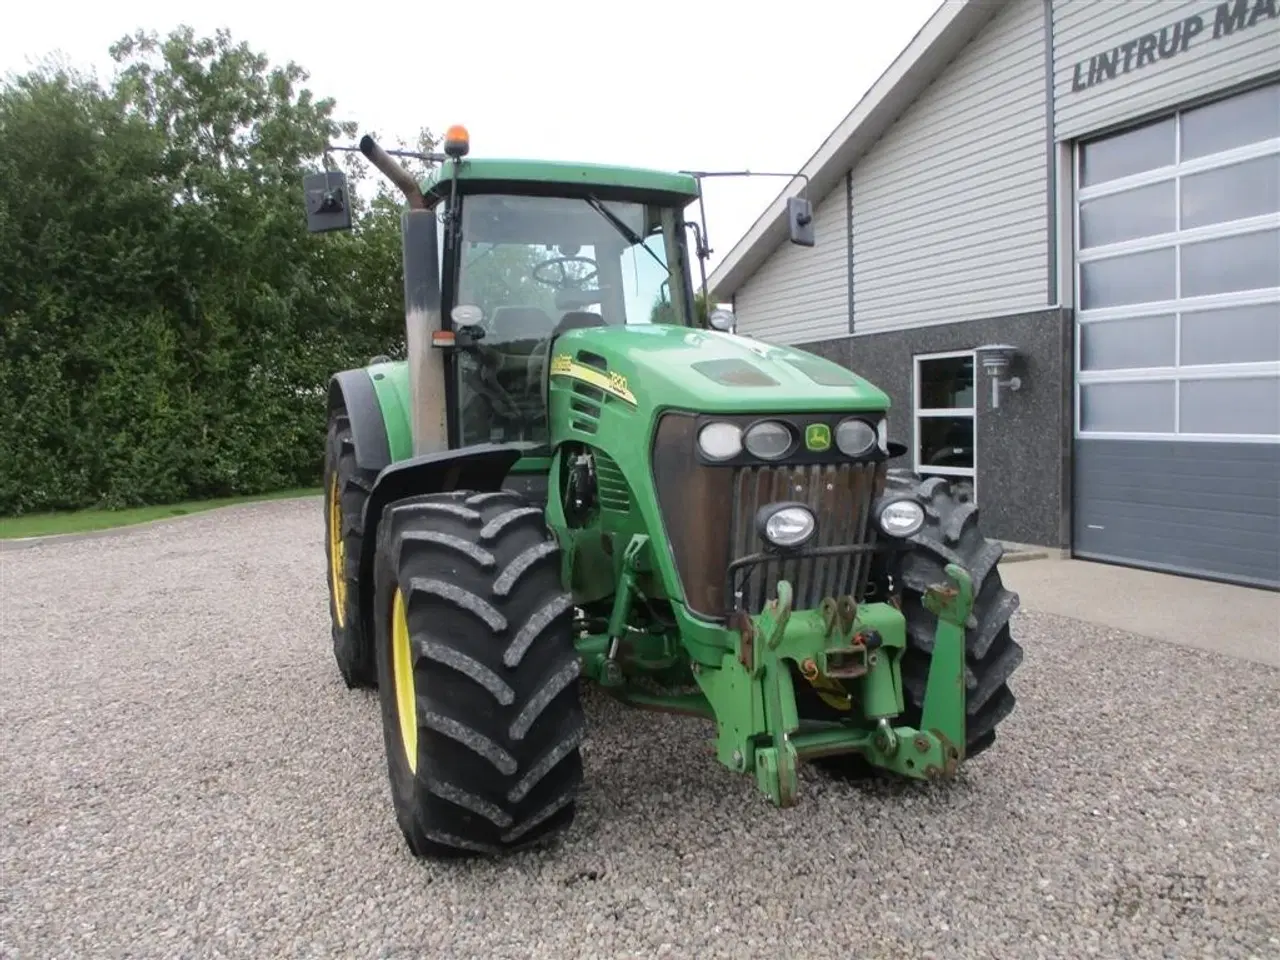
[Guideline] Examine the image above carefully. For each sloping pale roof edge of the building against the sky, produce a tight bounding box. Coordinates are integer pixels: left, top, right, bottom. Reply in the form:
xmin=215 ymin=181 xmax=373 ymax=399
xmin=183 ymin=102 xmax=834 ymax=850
xmin=707 ymin=0 xmax=1009 ymax=300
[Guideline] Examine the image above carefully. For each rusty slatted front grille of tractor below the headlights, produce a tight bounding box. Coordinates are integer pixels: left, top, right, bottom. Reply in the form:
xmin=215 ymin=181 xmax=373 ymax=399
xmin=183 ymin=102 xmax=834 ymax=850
xmin=727 ymin=463 xmax=881 ymax=613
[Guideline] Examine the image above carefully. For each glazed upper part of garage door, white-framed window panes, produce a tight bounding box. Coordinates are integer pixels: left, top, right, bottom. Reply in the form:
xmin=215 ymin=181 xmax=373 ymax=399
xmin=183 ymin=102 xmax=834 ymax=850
xmin=1075 ymin=83 xmax=1280 ymax=443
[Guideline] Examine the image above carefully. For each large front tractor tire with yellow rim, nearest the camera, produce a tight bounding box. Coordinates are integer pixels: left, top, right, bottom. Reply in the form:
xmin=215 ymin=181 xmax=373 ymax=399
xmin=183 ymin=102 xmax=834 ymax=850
xmin=374 ymin=490 xmax=585 ymax=856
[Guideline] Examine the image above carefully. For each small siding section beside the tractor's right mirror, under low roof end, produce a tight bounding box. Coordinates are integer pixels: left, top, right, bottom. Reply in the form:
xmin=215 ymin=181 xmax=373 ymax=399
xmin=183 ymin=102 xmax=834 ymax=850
xmin=733 ymin=180 xmax=849 ymax=343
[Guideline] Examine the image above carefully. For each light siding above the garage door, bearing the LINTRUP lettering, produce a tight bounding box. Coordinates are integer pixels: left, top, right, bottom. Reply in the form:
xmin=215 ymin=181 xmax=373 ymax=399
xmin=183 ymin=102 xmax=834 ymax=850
xmin=1053 ymin=0 xmax=1280 ymax=140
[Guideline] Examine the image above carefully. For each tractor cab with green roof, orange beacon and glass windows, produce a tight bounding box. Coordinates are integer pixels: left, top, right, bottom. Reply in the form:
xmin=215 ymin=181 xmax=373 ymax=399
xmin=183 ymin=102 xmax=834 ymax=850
xmin=305 ymin=127 xmax=703 ymax=463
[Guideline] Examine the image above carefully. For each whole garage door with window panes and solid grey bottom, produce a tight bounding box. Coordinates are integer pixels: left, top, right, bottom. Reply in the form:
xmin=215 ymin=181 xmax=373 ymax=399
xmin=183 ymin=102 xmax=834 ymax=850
xmin=1073 ymin=83 xmax=1280 ymax=586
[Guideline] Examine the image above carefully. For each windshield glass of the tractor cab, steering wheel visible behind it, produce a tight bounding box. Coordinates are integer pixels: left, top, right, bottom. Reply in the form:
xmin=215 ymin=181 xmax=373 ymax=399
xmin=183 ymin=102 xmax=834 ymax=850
xmin=452 ymin=195 xmax=690 ymax=445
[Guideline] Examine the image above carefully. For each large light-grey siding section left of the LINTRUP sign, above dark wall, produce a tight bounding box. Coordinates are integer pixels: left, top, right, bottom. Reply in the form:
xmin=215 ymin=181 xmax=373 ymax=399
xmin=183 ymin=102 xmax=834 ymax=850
xmin=852 ymin=0 xmax=1050 ymax=334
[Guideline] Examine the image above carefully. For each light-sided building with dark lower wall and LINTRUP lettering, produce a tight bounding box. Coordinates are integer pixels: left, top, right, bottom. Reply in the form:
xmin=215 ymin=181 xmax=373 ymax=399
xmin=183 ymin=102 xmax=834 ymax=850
xmin=710 ymin=0 xmax=1280 ymax=586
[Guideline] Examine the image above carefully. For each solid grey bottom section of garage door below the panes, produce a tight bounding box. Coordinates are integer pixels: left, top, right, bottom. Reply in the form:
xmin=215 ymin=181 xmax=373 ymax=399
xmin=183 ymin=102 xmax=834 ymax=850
xmin=1074 ymin=439 xmax=1280 ymax=586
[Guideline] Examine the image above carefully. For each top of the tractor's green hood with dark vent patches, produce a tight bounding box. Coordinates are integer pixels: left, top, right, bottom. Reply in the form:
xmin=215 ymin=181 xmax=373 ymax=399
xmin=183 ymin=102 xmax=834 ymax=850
xmin=552 ymin=324 xmax=890 ymax=413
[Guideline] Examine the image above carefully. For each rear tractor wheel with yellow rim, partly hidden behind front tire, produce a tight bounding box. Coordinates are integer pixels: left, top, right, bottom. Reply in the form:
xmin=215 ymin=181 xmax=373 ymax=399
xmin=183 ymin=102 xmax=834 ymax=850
xmin=324 ymin=406 xmax=378 ymax=690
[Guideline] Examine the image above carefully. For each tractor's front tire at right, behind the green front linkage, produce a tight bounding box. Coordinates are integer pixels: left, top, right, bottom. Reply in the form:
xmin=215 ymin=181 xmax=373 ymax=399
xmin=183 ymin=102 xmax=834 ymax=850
xmin=796 ymin=470 xmax=1023 ymax=778
